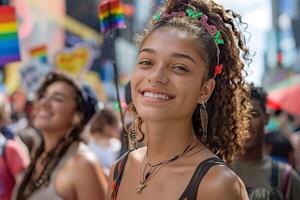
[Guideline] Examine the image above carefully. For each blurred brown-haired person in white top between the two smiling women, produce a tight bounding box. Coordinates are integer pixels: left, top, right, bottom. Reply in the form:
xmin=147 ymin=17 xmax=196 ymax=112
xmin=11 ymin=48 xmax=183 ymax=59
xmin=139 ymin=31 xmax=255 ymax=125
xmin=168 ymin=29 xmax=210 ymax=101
xmin=88 ymin=108 xmax=121 ymax=176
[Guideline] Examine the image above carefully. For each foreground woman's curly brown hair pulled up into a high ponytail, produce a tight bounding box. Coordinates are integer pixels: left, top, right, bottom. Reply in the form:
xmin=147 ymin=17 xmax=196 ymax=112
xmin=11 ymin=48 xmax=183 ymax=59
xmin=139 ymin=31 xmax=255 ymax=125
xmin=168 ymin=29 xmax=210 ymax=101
xmin=129 ymin=0 xmax=251 ymax=164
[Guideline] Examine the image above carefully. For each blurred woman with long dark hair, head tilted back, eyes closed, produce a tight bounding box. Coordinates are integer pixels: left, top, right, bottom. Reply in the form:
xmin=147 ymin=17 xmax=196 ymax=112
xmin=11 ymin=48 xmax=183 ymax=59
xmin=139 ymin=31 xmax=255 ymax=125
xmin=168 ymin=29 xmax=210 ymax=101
xmin=13 ymin=72 xmax=107 ymax=200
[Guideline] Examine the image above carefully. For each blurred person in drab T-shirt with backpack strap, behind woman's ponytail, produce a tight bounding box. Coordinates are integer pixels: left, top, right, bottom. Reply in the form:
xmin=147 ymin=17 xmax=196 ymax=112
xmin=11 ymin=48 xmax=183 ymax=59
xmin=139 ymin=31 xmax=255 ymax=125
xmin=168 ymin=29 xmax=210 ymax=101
xmin=233 ymin=84 xmax=300 ymax=200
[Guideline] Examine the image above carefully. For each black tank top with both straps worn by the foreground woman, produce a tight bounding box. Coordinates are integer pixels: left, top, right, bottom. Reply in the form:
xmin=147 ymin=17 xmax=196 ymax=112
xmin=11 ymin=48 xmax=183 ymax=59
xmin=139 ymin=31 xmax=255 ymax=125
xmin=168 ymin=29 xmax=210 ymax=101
xmin=110 ymin=152 xmax=226 ymax=200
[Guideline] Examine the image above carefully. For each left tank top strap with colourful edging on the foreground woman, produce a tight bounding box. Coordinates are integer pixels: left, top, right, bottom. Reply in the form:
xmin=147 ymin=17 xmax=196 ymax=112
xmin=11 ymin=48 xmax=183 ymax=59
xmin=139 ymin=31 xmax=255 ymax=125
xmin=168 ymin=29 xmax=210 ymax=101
xmin=110 ymin=151 xmax=131 ymax=200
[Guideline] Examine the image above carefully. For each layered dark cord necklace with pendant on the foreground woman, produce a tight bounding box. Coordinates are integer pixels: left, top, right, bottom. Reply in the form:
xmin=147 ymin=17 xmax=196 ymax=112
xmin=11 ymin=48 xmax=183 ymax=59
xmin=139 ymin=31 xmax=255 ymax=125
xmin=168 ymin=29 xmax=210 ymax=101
xmin=137 ymin=139 xmax=196 ymax=194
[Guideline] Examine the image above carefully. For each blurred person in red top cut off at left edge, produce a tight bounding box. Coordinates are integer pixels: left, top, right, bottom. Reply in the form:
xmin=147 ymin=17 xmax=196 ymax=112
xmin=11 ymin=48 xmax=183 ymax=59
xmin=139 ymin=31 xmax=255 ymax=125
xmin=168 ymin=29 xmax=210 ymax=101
xmin=0 ymin=96 xmax=29 ymax=200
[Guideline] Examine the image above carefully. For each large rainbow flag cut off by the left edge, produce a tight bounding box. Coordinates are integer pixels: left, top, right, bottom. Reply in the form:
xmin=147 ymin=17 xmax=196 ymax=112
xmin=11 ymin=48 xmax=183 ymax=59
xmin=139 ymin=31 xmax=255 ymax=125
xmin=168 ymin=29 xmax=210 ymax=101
xmin=0 ymin=6 xmax=20 ymax=66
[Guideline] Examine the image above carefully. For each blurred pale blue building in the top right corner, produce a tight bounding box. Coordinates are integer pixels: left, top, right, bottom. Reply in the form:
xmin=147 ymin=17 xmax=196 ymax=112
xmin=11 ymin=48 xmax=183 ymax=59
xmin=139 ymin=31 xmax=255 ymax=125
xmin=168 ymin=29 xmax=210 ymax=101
xmin=263 ymin=0 xmax=300 ymax=88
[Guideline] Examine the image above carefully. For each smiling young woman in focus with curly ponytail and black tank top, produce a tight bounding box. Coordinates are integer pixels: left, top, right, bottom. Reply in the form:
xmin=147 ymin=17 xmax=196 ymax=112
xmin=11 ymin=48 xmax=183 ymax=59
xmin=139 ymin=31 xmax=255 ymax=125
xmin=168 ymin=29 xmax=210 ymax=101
xmin=108 ymin=0 xmax=250 ymax=200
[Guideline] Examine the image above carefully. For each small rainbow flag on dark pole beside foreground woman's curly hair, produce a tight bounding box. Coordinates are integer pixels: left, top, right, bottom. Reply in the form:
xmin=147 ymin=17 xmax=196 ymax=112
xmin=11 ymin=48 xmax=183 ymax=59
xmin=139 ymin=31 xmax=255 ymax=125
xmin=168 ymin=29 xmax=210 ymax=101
xmin=99 ymin=0 xmax=126 ymax=33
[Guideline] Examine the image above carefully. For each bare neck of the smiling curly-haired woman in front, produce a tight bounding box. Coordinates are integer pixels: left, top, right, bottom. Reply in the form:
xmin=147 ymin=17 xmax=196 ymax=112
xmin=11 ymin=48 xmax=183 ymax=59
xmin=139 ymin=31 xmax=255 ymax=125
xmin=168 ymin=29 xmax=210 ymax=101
xmin=145 ymin=119 xmax=194 ymax=163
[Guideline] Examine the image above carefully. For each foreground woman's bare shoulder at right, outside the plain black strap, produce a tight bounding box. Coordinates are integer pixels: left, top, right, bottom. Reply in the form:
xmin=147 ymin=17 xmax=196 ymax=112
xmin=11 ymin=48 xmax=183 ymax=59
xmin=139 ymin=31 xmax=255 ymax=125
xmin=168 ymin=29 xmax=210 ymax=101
xmin=197 ymin=162 xmax=248 ymax=200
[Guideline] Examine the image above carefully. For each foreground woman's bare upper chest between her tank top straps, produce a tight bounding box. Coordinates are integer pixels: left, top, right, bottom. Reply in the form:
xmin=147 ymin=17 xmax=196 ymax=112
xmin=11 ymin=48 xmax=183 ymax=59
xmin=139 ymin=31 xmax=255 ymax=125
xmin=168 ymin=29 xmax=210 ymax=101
xmin=117 ymin=167 xmax=193 ymax=200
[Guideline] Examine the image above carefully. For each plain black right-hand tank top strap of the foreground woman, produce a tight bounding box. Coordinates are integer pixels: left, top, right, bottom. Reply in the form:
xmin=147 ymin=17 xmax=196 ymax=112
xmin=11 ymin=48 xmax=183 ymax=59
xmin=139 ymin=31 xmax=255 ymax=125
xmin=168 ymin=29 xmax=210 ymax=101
xmin=180 ymin=158 xmax=226 ymax=200
